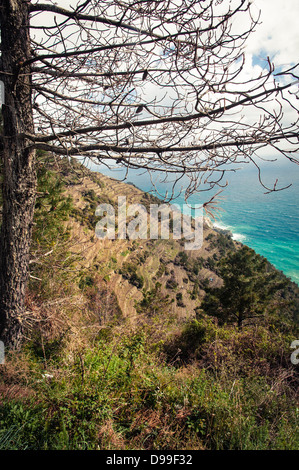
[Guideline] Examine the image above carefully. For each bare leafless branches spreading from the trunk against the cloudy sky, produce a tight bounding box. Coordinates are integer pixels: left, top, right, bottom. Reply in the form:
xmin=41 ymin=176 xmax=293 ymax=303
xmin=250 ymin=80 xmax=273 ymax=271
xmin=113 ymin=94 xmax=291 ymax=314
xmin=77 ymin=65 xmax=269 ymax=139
xmin=19 ymin=0 xmax=299 ymax=198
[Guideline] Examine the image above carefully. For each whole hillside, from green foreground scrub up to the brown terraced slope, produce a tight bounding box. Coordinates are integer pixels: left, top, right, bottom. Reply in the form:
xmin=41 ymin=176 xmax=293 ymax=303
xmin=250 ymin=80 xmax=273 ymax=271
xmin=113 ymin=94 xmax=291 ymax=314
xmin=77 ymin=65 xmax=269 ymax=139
xmin=0 ymin=155 xmax=299 ymax=449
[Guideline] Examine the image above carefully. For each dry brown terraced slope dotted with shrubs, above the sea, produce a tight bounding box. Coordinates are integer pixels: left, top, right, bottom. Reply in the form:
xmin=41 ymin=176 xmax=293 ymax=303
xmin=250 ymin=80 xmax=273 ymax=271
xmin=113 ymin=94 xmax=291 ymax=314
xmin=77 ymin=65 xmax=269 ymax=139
xmin=56 ymin=158 xmax=239 ymax=324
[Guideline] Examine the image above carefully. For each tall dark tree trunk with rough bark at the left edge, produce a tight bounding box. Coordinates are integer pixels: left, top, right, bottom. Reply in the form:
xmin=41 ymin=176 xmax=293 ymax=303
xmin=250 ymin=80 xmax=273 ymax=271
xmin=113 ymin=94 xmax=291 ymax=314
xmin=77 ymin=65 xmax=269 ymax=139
xmin=0 ymin=0 xmax=36 ymax=348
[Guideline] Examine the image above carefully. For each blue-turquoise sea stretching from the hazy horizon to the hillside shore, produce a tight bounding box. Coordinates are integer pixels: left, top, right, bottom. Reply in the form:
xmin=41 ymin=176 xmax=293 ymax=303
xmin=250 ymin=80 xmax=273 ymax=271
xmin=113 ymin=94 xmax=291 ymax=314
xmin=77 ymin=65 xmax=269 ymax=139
xmin=89 ymin=159 xmax=299 ymax=285
